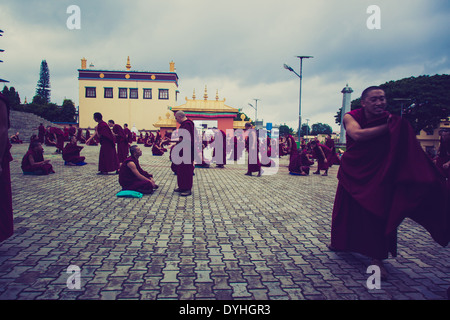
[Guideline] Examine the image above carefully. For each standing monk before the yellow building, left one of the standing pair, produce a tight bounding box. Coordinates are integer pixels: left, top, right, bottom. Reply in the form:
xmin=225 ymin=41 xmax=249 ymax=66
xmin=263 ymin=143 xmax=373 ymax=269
xmin=86 ymin=112 xmax=119 ymax=174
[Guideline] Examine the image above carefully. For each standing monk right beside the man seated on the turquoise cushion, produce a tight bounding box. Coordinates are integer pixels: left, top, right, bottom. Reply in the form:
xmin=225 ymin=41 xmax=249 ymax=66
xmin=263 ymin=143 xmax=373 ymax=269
xmin=172 ymin=111 xmax=195 ymax=197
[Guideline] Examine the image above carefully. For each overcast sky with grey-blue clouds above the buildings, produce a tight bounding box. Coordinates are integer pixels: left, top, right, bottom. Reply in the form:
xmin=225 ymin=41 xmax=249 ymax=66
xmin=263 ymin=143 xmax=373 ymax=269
xmin=0 ymin=0 xmax=450 ymax=131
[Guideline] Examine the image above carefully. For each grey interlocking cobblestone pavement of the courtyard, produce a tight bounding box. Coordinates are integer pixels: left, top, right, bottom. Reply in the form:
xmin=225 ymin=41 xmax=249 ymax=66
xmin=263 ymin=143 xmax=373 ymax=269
xmin=0 ymin=145 xmax=450 ymax=300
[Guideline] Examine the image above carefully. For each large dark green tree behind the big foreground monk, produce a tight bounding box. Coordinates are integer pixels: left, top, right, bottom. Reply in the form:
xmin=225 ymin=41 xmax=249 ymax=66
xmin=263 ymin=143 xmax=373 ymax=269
xmin=335 ymin=75 xmax=450 ymax=134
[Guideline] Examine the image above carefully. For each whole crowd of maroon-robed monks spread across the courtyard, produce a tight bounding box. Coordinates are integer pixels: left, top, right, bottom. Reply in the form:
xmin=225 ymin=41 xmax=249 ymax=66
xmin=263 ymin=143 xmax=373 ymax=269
xmin=0 ymin=87 xmax=450 ymax=284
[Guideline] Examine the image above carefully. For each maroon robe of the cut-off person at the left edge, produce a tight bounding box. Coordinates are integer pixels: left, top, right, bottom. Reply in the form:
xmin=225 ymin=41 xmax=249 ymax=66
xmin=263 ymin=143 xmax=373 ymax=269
xmin=0 ymin=93 xmax=14 ymax=242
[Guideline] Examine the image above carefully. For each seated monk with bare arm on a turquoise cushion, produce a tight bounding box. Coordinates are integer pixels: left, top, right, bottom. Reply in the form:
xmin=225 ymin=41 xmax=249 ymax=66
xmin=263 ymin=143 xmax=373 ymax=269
xmin=119 ymin=145 xmax=158 ymax=194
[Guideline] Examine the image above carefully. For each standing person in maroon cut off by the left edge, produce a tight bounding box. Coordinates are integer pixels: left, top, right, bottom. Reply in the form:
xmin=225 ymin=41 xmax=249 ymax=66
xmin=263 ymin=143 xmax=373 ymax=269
xmin=0 ymin=93 xmax=14 ymax=242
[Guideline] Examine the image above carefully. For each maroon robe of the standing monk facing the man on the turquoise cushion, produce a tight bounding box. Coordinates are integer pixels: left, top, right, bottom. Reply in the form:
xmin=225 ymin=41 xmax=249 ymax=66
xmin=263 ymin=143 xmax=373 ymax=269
xmin=176 ymin=119 xmax=195 ymax=191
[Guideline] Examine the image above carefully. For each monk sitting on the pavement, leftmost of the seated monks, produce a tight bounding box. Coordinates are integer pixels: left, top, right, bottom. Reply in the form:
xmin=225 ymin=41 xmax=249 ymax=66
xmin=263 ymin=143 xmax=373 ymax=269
xmin=22 ymin=141 xmax=55 ymax=175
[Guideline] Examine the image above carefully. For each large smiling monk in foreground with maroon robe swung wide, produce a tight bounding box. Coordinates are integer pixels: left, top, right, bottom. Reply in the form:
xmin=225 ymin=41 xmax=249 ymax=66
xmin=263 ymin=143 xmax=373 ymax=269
xmin=329 ymin=87 xmax=450 ymax=277
